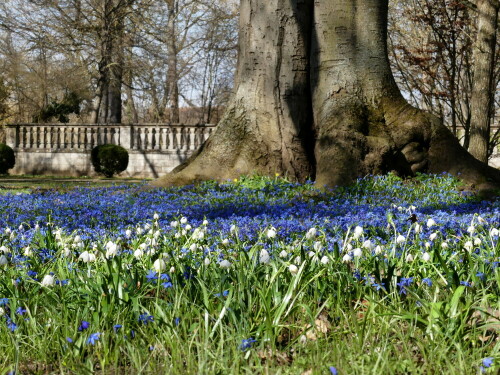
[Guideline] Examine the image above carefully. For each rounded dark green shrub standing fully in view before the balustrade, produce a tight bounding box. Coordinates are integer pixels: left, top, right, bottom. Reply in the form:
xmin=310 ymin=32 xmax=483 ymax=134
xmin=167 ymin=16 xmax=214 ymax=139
xmin=91 ymin=145 xmax=128 ymax=177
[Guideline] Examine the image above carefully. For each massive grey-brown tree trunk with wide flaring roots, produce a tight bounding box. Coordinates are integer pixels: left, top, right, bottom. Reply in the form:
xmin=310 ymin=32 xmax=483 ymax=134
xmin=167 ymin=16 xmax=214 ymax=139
xmin=157 ymin=0 xmax=500 ymax=192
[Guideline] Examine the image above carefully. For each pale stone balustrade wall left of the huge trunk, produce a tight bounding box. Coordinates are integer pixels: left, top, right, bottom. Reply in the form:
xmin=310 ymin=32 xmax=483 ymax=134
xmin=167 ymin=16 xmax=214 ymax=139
xmin=6 ymin=124 xmax=215 ymax=178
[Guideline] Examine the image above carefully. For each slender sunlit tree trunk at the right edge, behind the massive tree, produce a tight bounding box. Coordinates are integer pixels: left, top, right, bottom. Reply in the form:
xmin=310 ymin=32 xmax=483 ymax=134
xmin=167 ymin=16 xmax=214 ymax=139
xmin=469 ymin=0 xmax=500 ymax=163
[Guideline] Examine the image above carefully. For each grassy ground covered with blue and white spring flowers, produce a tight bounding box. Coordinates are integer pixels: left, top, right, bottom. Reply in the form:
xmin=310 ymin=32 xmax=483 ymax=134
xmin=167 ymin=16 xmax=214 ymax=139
xmin=0 ymin=175 xmax=500 ymax=375
